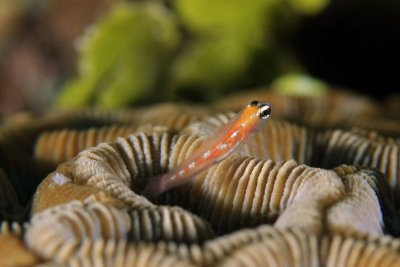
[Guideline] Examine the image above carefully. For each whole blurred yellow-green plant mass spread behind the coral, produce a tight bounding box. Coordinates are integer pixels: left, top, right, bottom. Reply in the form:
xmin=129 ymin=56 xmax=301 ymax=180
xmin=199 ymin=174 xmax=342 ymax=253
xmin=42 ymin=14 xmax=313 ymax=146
xmin=55 ymin=0 xmax=327 ymax=107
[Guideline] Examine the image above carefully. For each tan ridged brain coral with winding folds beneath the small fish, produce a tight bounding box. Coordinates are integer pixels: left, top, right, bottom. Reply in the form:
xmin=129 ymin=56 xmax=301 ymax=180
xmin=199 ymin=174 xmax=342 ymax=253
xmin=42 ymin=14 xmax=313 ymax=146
xmin=0 ymin=90 xmax=400 ymax=267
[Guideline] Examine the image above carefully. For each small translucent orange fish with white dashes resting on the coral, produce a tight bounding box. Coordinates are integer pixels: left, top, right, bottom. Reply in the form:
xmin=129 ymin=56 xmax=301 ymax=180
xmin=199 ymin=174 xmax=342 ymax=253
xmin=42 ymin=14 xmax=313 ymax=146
xmin=142 ymin=100 xmax=271 ymax=199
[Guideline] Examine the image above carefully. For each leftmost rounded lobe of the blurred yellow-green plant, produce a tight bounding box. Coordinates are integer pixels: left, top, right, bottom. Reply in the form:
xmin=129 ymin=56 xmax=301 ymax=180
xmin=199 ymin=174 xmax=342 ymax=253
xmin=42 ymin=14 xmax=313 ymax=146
xmin=58 ymin=2 xmax=180 ymax=107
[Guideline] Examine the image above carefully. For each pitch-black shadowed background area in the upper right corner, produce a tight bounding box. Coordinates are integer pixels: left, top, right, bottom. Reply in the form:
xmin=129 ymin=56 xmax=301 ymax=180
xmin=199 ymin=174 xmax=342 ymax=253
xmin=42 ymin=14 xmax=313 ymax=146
xmin=290 ymin=0 xmax=400 ymax=98
